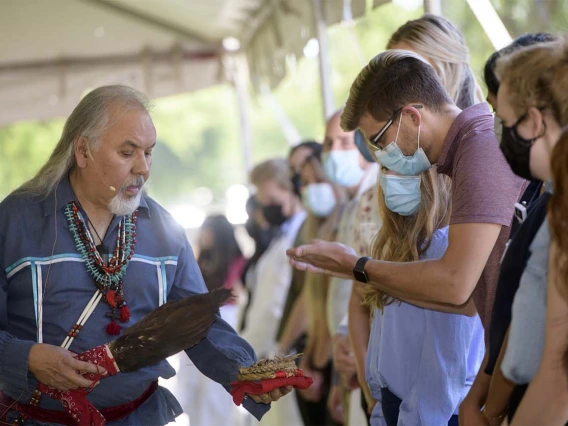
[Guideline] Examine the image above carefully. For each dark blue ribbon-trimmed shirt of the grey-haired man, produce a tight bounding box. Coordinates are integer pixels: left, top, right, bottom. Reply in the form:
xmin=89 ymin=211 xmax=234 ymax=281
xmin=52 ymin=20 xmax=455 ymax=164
xmin=0 ymin=178 xmax=269 ymax=425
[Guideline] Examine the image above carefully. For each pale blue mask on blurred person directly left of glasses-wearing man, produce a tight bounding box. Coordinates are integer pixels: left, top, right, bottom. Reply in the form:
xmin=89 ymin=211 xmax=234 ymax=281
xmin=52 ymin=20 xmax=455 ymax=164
xmin=321 ymin=149 xmax=365 ymax=187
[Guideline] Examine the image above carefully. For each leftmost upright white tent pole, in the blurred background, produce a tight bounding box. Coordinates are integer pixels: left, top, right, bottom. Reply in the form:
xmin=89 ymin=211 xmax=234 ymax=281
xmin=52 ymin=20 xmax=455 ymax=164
xmin=229 ymin=55 xmax=252 ymax=175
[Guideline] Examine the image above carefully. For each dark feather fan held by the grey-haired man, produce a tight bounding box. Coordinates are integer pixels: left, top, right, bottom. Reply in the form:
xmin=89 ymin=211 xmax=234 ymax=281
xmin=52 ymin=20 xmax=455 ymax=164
xmin=109 ymin=289 xmax=232 ymax=372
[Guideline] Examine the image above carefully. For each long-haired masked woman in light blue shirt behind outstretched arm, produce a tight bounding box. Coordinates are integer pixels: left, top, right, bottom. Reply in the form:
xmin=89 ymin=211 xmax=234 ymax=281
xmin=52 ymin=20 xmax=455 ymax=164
xmin=363 ymin=168 xmax=485 ymax=426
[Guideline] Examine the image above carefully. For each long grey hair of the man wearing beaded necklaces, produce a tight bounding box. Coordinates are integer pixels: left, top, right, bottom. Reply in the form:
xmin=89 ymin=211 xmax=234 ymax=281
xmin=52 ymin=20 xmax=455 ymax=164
xmin=16 ymin=85 xmax=152 ymax=197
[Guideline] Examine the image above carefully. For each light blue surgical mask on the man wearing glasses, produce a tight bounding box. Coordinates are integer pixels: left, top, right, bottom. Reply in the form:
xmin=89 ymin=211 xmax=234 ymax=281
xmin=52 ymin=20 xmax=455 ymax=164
xmin=375 ymin=115 xmax=432 ymax=176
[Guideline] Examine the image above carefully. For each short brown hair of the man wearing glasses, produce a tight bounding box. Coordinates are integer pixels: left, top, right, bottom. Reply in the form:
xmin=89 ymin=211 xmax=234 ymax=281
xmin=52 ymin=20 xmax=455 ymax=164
xmin=341 ymin=49 xmax=452 ymax=131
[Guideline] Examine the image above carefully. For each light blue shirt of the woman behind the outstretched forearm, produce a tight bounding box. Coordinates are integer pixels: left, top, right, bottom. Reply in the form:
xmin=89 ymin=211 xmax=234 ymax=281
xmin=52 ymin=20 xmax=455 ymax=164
xmin=365 ymin=227 xmax=485 ymax=426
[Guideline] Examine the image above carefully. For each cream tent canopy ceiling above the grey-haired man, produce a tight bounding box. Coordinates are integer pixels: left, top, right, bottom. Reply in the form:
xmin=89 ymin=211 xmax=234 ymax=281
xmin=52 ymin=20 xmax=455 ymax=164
xmin=0 ymin=0 xmax=384 ymax=125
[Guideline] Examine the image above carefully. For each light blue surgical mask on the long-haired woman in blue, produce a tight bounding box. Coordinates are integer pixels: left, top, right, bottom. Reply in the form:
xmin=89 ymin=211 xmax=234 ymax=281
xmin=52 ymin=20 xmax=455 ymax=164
xmin=379 ymin=173 xmax=420 ymax=216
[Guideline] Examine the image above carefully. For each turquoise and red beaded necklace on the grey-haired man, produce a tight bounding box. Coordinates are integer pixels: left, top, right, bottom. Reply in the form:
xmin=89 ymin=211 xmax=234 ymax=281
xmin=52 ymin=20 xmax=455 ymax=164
xmin=65 ymin=201 xmax=138 ymax=337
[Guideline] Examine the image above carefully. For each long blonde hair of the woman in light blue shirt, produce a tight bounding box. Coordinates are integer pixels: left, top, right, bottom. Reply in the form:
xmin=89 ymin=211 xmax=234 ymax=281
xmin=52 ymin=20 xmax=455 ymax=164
xmin=361 ymin=169 xmax=451 ymax=310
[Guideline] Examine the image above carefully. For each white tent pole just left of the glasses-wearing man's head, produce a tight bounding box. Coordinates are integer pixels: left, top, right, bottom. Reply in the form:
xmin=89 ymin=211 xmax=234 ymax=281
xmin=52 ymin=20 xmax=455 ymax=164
xmin=312 ymin=0 xmax=335 ymax=121
